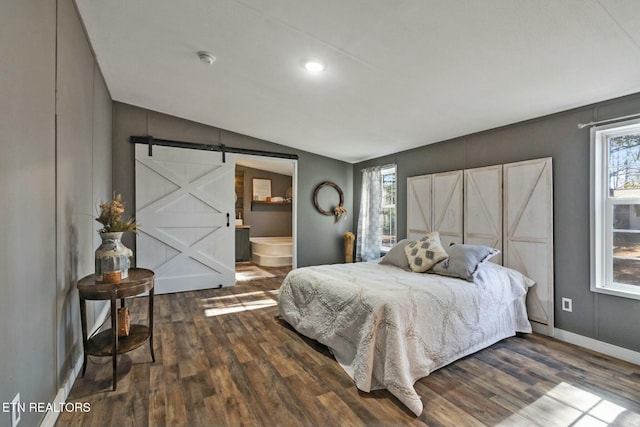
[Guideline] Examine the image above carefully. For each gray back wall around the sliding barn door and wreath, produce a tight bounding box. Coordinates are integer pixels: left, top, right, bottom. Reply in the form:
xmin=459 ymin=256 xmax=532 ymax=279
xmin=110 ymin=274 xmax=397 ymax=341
xmin=113 ymin=102 xmax=353 ymax=267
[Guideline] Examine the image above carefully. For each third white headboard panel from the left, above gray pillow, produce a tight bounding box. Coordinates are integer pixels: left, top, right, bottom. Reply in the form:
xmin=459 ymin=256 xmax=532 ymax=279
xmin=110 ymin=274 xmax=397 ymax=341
xmin=464 ymin=165 xmax=503 ymax=264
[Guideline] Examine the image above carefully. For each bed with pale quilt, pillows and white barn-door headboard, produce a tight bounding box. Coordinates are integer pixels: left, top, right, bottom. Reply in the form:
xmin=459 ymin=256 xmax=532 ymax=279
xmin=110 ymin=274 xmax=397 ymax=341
xmin=279 ymin=157 xmax=554 ymax=416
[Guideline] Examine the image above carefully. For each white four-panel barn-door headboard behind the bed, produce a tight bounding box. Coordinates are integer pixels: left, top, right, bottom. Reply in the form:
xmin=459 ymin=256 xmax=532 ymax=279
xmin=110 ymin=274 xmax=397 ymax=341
xmin=407 ymin=157 xmax=554 ymax=335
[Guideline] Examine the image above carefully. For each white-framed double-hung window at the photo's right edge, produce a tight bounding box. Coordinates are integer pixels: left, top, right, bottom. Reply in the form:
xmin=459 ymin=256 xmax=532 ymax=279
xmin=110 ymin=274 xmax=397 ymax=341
xmin=591 ymin=120 xmax=640 ymax=299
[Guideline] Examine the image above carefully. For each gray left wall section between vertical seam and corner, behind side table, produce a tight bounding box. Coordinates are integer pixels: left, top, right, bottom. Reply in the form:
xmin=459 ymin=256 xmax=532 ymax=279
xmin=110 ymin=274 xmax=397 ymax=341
xmin=56 ymin=0 xmax=112 ymax=390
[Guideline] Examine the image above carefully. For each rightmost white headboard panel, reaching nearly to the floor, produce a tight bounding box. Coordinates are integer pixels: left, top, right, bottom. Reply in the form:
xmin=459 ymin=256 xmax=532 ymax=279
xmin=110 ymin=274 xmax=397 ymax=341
xmin=504 ymin=158 xmax=553 ymax=335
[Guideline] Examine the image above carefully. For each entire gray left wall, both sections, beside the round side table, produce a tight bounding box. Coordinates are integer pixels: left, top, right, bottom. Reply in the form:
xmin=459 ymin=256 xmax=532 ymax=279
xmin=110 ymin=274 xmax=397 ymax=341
xmin=0 ymin=0 xmax=111 ymax=426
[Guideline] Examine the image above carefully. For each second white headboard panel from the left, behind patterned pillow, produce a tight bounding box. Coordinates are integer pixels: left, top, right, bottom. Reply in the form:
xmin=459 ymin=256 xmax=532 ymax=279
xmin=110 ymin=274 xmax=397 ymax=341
xmin=431 ymin=170 xmax=463 ymax=247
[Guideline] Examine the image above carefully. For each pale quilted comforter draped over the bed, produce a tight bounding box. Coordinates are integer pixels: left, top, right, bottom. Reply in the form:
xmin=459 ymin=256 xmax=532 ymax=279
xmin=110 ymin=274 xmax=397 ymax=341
xmin=279 ymin=262 xmax=534 ymax=415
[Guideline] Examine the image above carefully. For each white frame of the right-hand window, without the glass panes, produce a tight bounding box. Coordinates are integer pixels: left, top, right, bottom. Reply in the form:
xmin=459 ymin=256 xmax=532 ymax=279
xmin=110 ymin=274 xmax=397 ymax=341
xmin=590 ymin=119 xmax=640 ymax=299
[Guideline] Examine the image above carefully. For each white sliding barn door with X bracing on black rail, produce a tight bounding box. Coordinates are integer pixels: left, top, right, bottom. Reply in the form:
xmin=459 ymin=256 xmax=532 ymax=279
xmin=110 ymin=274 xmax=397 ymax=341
xmin=135 ymin=144 xmax=235 ymax=293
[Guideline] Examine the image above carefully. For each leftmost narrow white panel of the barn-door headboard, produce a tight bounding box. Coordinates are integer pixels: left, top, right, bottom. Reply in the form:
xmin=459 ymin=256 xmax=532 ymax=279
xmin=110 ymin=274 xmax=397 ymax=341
xmin=407 ymin=175 xmax=432 ymax=240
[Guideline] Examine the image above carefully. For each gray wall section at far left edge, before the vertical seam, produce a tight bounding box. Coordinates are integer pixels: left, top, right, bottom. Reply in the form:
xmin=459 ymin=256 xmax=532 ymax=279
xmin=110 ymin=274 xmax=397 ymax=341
xmin=0 ymin=0 xmax=57 ymax=426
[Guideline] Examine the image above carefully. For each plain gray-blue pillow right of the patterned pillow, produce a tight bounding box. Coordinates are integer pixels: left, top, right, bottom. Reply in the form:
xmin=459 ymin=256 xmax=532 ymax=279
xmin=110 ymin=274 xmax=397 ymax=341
xmin=431 ymin=245 xmax=500 ymax=282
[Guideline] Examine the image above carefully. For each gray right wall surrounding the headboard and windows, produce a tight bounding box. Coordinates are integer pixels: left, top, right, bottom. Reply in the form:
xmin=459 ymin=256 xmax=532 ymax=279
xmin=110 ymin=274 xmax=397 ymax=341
xmin=354 ymin=94 xmax=640 ymax=351
